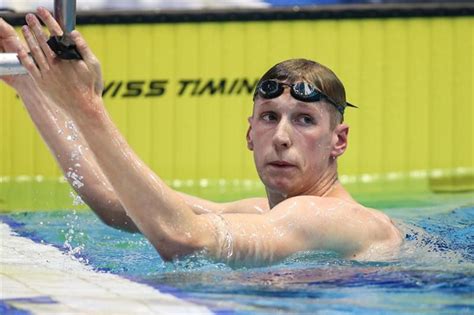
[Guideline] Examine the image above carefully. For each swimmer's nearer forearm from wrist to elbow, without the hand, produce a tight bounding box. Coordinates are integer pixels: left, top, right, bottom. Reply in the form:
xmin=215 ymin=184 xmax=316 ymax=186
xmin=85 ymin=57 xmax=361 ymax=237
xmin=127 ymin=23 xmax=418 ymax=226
xmin=69 ymin=97 xmax=212 ymax=258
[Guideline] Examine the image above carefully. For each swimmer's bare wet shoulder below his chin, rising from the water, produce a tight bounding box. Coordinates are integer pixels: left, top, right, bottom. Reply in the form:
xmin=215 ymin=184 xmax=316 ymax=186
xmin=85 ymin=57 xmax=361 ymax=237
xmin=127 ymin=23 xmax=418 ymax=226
xmin=264 ymin=196 xmax=402 ymax=260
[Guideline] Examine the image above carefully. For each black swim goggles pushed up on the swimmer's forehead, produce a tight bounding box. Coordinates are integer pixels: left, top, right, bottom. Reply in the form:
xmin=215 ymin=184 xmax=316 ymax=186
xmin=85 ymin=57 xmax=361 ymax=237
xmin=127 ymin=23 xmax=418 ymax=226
xmin=254 ymin=80 xmax=357 ymax=114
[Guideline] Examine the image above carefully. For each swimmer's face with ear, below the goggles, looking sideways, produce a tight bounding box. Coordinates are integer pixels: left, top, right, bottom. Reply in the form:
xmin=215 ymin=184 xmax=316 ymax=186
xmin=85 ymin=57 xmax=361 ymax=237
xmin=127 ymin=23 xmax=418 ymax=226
xmin=247 ymin=89 xmax=347 ymax=196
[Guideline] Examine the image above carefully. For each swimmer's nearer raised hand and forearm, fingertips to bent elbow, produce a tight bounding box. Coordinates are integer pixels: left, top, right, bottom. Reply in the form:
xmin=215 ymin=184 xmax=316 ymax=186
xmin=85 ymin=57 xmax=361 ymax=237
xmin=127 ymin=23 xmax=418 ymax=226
xmin=13 ymin=9 xmax=235 ymax=258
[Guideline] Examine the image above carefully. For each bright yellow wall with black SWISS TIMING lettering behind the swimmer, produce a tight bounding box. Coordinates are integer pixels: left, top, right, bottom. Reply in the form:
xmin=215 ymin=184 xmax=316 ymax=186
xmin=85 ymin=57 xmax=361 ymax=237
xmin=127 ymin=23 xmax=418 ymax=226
xmin=0 ymin=17 xmax=474 ymax=209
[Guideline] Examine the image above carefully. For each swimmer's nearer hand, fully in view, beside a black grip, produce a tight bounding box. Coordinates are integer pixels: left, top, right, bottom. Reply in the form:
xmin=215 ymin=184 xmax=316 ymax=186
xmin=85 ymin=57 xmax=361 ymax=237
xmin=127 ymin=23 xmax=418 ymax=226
xmin=18 ymin=8 xmax=103 ymax=112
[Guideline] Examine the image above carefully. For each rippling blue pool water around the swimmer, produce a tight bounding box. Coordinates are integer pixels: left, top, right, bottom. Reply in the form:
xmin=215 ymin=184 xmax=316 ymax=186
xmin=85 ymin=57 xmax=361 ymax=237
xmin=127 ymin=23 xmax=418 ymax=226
xmin=0 ymin=195 xmax=474 ymax=314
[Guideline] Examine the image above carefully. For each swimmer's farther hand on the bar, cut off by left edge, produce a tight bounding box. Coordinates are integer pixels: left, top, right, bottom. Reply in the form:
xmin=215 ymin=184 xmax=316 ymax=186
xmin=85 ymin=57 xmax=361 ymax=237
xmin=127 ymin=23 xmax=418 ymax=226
xmin=0 ymin=18 xmax=34 ymax=93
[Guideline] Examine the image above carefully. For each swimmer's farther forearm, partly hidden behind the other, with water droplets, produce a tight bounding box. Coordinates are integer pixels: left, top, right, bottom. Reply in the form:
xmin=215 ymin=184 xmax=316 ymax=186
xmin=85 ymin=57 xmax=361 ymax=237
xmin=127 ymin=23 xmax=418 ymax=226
xmin=20 ymin=86 xmax=138 ymax=232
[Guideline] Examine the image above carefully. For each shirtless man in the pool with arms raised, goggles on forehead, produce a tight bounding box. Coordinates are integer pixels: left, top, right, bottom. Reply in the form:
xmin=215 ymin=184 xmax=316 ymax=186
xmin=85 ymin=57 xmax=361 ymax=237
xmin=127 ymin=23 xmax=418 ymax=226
xmin=0 ymin=8 xmax=402 ymax=264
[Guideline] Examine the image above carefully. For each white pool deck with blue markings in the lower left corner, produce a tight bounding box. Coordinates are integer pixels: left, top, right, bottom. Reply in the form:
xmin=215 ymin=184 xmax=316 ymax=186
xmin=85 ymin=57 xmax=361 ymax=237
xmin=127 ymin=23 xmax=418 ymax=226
xmin=0 ymin=223 xmax=212 ymax=314
